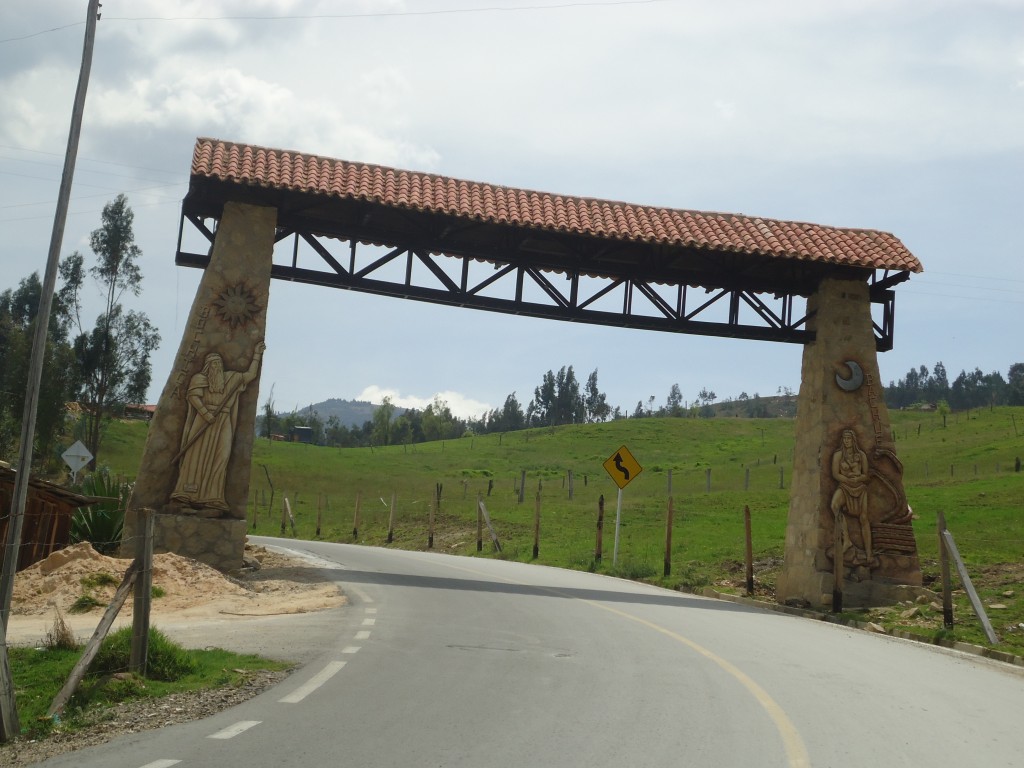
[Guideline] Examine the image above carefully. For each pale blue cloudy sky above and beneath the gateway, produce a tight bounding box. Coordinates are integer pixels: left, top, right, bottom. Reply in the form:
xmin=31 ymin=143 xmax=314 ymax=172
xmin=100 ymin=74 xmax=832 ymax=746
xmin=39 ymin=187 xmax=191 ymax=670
xmin=0 ymin=0 xmax=1024 ymax=415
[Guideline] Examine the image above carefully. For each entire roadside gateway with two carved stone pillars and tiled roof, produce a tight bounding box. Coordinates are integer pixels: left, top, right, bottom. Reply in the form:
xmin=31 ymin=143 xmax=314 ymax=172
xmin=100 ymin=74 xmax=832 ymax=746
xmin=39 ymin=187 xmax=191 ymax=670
xmin=125 ymin=138 xmax=922 ymax=605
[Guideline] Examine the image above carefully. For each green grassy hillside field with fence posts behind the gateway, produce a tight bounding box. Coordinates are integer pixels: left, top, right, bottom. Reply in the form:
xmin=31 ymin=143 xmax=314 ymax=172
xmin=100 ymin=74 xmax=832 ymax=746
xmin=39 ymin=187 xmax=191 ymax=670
xmin=102 ymin=408 xmax=1024 ymax=651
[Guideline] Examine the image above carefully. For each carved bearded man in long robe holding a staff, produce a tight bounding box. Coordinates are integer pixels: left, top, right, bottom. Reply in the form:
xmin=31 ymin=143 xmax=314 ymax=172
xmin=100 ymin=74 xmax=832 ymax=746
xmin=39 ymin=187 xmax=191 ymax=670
xmin=171 ymin=341 xmax=266 ymax=511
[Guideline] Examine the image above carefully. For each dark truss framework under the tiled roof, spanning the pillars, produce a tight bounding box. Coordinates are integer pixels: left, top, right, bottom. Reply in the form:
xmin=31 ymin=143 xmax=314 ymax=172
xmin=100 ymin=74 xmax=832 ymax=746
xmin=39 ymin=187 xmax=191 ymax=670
xmin=176 ymin=189 xmax=909 ymax=351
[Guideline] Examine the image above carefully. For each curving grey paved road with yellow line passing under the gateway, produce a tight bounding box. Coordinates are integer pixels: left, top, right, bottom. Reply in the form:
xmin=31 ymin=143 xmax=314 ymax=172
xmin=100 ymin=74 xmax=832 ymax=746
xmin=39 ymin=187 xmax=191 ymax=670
xmin=36 ymin=538 xmax=1024 ymax=768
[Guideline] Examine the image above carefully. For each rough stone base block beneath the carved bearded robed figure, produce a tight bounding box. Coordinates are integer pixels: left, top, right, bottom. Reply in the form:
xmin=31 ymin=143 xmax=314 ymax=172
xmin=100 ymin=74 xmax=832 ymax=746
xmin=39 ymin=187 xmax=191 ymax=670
xmin=121 ymin=508 xmax=248 ymax=572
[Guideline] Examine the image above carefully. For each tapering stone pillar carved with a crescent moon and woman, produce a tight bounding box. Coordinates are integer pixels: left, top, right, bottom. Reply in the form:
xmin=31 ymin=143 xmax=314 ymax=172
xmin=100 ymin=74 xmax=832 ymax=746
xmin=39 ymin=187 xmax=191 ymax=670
xmin=776 ymin=279 xmax=922 ymax=607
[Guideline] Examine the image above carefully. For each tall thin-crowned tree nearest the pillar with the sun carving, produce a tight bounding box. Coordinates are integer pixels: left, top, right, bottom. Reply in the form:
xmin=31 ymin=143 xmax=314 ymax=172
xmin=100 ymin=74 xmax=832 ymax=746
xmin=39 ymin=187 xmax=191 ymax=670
xmin=60 ymin=195 xmax=160 ymax=461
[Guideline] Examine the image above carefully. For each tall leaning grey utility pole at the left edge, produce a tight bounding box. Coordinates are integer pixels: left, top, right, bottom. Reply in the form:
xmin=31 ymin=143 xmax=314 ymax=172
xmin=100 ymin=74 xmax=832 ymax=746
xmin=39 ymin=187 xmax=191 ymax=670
xmin=0 ymin=0 xmax=99 ymax=742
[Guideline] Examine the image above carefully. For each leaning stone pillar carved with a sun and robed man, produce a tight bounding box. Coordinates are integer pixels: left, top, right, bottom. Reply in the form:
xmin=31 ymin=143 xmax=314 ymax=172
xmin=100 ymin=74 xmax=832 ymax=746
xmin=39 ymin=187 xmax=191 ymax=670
xmin=122 ymin=203 xmax=276 ymax=570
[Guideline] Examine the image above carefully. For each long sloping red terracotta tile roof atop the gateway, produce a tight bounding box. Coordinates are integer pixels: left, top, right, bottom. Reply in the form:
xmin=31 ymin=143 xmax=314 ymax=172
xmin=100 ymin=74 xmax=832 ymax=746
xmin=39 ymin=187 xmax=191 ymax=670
xmin=191 ymin=138 xmax=922 ymax=272
